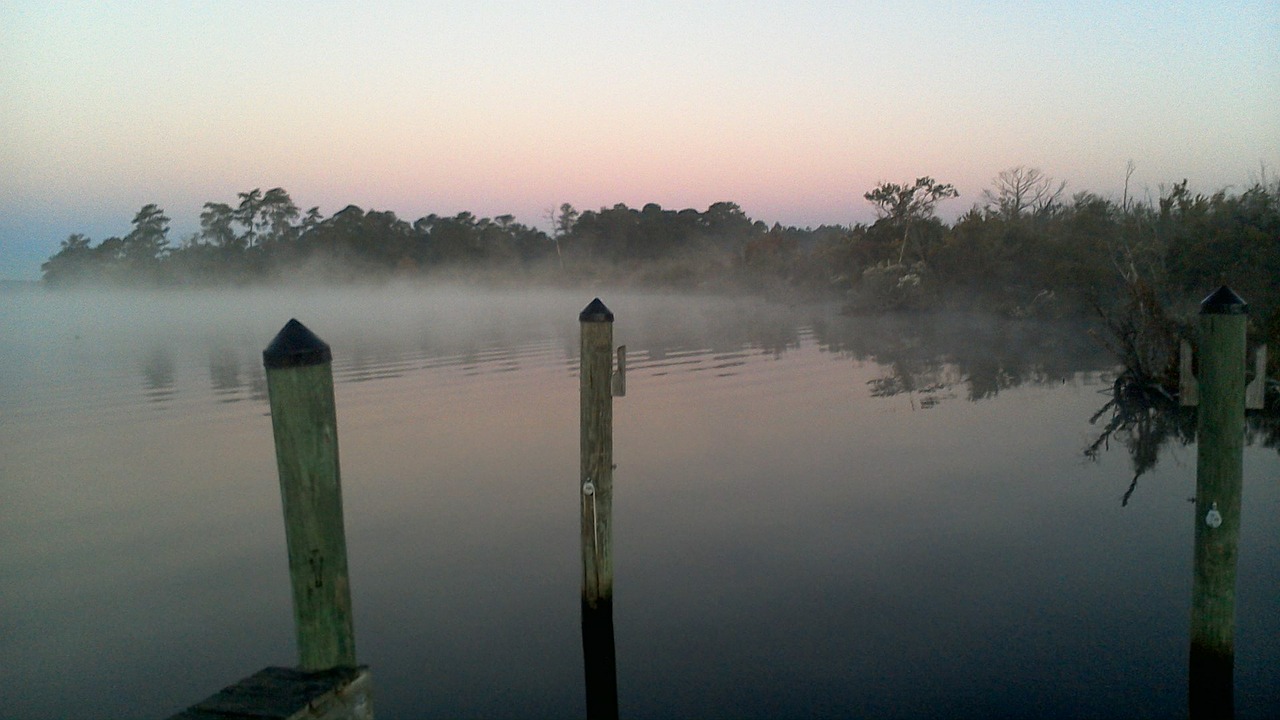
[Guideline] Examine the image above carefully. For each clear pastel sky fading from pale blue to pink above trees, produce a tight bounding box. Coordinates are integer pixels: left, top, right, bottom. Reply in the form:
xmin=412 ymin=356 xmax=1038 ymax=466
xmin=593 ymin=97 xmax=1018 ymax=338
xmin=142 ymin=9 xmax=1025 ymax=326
xmin=0 ymin=0 xmax=1280 ymax=279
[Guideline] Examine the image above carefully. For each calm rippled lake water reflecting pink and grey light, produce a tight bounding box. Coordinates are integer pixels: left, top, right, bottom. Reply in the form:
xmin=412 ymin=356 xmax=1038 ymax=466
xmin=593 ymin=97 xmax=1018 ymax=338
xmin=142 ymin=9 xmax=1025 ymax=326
xmin=0 ymin=283 xmax=1280 ymax=719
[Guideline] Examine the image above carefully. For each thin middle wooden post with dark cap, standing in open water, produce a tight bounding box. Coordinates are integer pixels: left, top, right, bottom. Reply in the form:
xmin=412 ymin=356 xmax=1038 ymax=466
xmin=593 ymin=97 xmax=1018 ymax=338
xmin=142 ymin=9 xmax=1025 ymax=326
xmin=577 ymin=297 xmax=626 ymax=720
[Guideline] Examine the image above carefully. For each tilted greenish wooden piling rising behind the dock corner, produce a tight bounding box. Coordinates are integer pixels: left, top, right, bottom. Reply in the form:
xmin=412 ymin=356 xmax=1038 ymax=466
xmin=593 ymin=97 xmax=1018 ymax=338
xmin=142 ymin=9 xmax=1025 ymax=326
xmin=262 ymin=320 xmax=356 ymax=671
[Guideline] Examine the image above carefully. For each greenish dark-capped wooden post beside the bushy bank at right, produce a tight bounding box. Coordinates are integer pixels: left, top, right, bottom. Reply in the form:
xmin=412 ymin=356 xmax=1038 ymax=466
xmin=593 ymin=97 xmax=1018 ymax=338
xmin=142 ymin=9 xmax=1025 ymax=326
xmin=1188 ymin=286 xmax=1248 ymax=719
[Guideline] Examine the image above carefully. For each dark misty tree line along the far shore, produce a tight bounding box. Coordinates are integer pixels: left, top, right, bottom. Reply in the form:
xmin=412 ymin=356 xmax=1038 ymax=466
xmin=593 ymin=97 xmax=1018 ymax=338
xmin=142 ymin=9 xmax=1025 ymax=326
xmin=42 ymin=167 xmax=1280 ymax=336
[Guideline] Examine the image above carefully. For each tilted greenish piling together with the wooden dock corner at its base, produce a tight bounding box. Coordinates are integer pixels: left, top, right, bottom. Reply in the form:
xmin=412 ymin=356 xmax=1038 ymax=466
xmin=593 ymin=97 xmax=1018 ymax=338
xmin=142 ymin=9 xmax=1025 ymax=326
xmin=169 ymin=320 xmax=374 ymax=720
